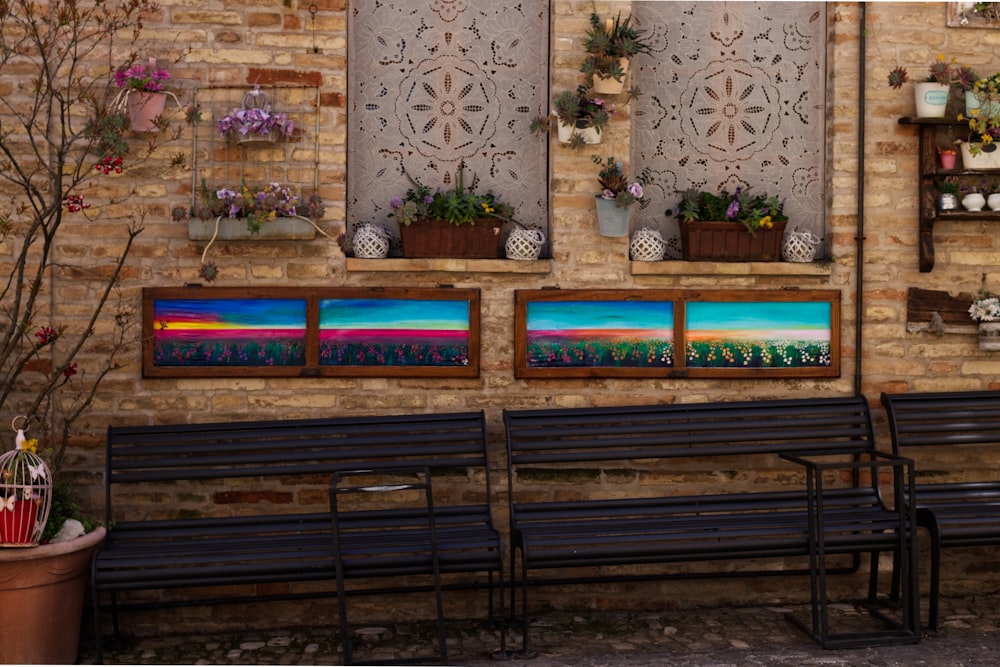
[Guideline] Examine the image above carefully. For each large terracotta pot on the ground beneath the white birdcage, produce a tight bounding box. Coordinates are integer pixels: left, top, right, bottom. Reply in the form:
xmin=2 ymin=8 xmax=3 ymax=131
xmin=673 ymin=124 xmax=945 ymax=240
xmin=0 ymin=528 xmax=105 ymax=665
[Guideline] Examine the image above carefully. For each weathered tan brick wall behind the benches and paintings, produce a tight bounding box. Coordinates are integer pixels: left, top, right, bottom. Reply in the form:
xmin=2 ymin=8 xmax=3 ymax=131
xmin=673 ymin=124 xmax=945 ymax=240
xmin=13 ymin=0 xmax=1000 ymax=622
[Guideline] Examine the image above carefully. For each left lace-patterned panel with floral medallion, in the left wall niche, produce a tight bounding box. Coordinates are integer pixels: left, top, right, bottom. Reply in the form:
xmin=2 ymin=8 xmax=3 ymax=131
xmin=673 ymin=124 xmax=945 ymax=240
xmin=347 ymin=0 xmax=549 ymax=252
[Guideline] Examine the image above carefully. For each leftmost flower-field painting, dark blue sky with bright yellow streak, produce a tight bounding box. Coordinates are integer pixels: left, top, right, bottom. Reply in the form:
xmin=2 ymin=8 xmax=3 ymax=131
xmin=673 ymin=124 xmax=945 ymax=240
xmin=153 ymin=299 xmax=306 ymax=366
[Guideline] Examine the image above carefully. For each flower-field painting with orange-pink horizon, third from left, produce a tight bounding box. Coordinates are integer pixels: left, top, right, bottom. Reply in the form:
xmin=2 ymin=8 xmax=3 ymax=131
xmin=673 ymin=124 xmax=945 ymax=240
xmin=525 ymin=301 xmax=674 ymax=368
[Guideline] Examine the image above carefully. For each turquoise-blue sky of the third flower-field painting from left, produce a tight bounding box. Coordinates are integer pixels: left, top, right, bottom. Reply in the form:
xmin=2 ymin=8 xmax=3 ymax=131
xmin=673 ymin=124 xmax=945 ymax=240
xmin=527 ymin=301 xmax=674 ymax=331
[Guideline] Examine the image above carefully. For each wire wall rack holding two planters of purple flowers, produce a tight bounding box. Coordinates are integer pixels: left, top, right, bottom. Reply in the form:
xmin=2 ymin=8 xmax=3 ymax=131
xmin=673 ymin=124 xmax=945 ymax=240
xmin=188 ymin=84 xmax=322 ymax=281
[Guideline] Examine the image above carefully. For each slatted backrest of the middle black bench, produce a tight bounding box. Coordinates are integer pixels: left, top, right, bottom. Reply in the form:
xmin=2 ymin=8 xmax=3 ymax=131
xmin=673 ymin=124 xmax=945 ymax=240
xmin=504 ymin=397 xmax=875 ymax=505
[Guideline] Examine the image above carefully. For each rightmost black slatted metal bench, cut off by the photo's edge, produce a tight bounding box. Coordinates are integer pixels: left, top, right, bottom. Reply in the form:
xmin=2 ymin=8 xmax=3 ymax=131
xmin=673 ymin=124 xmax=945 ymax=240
xmin=882 ymin=391 xmax=1000 ymax=631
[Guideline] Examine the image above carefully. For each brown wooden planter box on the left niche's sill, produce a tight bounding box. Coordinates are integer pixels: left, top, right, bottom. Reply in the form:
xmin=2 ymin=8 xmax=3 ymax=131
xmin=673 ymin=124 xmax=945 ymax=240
xmin=399 ymin=218 xmax=503 ymax=259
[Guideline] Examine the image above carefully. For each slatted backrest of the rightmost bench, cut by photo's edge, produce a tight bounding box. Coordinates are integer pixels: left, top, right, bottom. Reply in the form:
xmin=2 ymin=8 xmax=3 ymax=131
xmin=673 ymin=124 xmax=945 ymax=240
xmin=882 ymin=391 xmax=1000 ymax=455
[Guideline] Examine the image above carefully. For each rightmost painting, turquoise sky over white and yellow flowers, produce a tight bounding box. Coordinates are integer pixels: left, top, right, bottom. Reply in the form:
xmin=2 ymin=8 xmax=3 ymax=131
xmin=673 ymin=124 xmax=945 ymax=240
xmin=684 ymin=301 xmax=833 ymax=368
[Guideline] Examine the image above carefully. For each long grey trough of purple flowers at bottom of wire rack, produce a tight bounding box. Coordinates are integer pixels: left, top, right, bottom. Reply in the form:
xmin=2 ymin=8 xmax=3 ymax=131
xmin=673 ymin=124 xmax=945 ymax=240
xmin=187 ymin=179 xmax=324 ymax=282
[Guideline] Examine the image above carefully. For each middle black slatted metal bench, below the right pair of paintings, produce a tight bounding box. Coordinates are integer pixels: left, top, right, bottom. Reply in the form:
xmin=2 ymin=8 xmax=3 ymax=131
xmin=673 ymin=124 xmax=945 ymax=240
xmin=504 ymin=397 xmax=920 ymax=652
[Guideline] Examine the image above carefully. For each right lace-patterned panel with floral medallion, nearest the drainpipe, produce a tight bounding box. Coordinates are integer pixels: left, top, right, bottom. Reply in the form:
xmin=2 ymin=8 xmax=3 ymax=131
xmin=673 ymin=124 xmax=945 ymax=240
xmin=626 ymin=2 xmax=827 ymax=257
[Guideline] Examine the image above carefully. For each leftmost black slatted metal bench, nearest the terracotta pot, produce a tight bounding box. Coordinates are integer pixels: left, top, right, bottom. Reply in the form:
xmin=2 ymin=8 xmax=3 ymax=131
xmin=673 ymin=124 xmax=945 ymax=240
xmin=93 ymin=411 xmax=504 ymax=662
